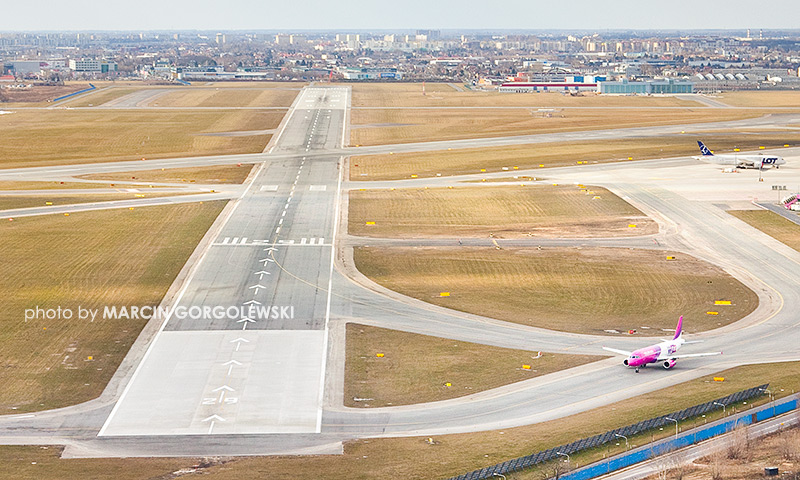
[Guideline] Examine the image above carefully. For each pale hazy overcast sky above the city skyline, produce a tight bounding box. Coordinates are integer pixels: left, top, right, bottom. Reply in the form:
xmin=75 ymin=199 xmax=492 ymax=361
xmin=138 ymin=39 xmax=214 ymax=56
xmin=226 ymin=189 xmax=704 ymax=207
xmin=0 ymin=0 xmax=800 ymax=31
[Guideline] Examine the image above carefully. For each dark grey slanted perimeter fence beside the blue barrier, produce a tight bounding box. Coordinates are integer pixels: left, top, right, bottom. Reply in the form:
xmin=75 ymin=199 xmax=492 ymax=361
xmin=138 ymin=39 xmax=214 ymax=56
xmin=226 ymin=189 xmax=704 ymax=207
xmin=450 ymin=383 xmax=769 ymax=480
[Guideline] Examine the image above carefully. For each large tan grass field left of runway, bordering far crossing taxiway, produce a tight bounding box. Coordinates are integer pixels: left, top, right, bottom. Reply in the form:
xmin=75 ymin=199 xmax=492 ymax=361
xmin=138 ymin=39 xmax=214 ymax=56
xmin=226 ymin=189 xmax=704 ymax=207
xmin=0 ymin=110 xmax=285 ymax=168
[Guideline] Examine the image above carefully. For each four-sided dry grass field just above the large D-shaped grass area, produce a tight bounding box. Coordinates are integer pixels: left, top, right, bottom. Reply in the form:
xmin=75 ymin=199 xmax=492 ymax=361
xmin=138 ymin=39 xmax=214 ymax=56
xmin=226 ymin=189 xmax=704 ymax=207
xmin=347 ymin=185 xmax=658 ymax=238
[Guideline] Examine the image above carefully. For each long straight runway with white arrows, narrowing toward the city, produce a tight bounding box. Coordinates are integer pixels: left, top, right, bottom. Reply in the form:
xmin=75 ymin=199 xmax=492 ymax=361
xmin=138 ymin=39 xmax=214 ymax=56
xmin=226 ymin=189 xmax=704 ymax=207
xmin=99 ymin=88 xmax=348 ymax=436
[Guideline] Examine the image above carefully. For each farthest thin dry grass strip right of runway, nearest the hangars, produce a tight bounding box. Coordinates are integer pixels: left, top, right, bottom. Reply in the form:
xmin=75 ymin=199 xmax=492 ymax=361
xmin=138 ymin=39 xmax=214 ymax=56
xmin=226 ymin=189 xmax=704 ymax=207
xmin=352 ymin=83 xmax=700 ymax=107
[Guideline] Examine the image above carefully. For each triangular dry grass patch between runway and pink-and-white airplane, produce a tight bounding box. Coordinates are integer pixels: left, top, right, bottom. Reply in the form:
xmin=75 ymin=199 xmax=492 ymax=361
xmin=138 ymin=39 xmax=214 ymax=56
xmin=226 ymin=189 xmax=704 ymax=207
xmin=344 ymin=323 xmax=605 ymax=407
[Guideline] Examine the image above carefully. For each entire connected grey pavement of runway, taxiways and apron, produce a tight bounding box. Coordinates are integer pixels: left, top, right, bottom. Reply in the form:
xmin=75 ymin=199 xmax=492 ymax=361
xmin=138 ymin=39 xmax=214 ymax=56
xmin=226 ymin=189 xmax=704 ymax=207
xmin=0 ymin=87 xmax=800 ymax=457
